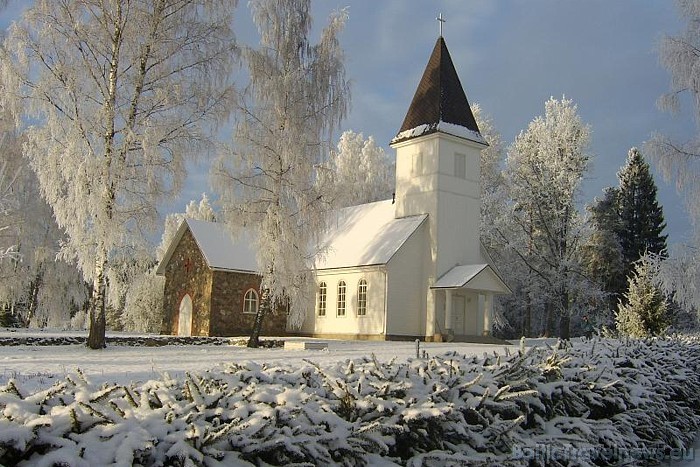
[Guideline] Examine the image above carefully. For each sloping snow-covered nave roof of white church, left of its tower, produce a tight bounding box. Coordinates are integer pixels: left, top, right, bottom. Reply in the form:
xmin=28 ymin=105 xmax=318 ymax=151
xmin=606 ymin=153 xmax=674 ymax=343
xmin=316 ymin=200 xmax=428 ymax=269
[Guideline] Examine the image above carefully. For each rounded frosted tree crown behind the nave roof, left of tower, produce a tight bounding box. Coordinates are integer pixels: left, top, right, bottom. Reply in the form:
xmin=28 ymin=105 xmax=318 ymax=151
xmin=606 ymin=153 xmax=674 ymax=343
xmin=330 ymin=130 xmax=394 ymax=207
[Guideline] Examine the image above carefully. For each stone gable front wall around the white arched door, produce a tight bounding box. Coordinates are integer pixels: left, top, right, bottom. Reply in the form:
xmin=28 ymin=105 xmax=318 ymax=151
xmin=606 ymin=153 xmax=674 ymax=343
xmin=162 ymin=228 xmax=212 ymax=336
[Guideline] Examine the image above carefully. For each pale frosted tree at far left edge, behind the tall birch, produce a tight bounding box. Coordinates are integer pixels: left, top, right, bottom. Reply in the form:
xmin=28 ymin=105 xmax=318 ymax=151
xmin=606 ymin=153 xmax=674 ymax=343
xmin=0 ymin=115 xmax=87 ymax=328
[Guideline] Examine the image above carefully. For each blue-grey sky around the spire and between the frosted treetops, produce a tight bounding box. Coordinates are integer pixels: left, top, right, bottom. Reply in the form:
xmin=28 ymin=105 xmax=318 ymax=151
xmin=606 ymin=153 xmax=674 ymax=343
xmin=2 ymin=0 xmax=697 ymax=242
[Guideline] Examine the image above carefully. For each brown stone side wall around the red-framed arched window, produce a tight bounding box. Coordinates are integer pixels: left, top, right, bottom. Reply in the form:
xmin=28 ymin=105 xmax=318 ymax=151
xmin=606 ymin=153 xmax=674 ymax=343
xmin=210 ymin=271 xmax=287 ymax=336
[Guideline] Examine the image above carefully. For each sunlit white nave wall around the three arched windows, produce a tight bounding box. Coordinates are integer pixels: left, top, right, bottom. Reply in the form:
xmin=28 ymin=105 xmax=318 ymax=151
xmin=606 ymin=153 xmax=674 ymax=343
xmin=300 ymin=267 xmax=386 ymax=337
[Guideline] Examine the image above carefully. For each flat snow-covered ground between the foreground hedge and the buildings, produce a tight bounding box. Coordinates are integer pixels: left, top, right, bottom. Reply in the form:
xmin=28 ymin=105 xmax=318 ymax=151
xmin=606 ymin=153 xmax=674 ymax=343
xmin=0 ymin=329 xmax=516 ymax=390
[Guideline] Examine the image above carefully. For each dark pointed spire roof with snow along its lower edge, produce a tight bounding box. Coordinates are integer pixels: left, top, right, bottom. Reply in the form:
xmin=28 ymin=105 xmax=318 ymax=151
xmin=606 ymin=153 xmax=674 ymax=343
xmin=391 ymin=36 xmax=486 ymax=144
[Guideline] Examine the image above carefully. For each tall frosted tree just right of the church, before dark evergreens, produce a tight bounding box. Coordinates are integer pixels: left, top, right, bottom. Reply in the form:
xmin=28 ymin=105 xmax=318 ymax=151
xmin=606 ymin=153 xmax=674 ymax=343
xmin=501 ymin=98 xmax=591 ymax=339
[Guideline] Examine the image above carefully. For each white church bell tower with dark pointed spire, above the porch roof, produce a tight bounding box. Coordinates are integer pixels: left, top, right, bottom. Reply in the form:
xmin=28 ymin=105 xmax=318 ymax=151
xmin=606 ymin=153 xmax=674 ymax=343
xmin=391 ymin=36 xmax=487 ymax=282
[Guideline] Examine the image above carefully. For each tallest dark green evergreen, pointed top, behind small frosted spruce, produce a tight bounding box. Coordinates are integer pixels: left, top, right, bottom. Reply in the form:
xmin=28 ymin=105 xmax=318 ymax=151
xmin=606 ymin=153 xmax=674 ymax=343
xmin=617 ymin=148 xmax=667 ymax=277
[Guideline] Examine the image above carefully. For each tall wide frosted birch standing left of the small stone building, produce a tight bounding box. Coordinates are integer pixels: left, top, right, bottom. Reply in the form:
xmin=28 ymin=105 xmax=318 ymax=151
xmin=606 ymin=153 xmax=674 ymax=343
xmin=0 ymin=0 xmax=236 ymax=348
